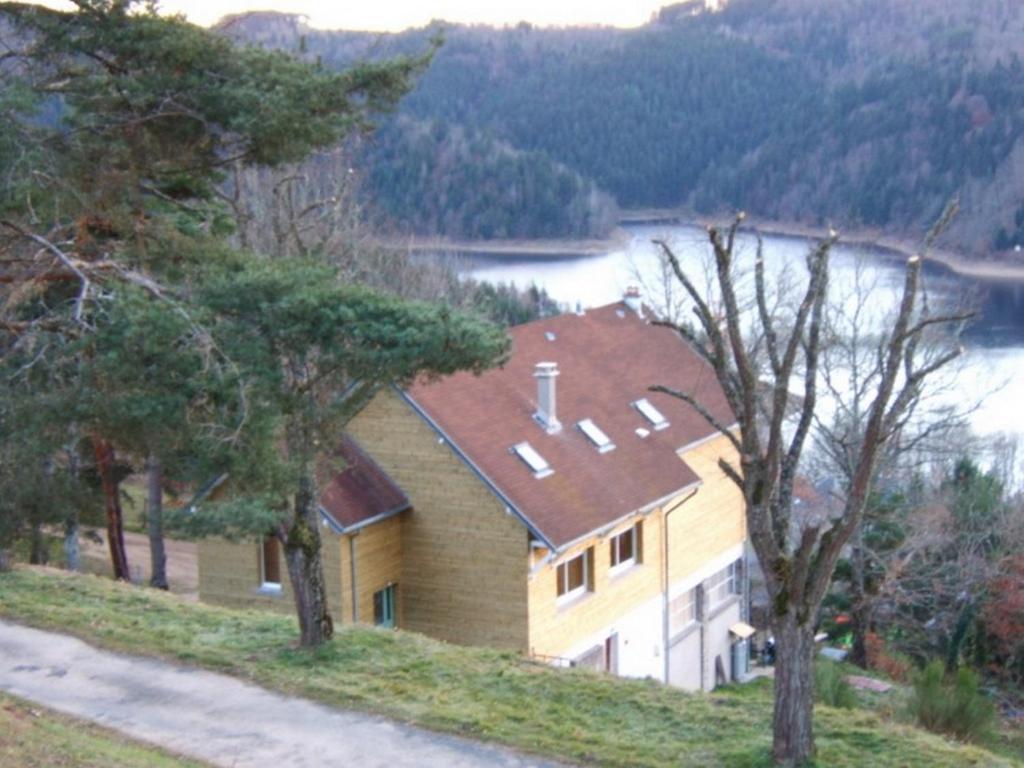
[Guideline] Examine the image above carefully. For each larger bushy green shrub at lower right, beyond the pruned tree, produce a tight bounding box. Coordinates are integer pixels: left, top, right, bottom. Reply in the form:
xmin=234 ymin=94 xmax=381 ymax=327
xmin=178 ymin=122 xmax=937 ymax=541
xmin=909 ymin=660 xmax=995 ymax=741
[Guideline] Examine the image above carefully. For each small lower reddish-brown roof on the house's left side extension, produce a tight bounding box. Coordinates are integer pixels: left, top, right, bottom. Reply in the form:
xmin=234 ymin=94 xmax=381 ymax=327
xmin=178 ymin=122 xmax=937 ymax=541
xmin=319 ymin=435 xmax=410 ymax=530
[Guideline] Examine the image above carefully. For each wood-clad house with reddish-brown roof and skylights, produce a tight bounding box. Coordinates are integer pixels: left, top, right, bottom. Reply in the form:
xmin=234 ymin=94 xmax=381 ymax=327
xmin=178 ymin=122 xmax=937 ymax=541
xmin=200 ymin=295 xmax=751 ymax=689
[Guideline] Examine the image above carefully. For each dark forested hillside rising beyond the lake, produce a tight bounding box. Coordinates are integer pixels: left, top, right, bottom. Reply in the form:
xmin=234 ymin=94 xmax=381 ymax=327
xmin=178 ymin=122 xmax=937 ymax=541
xmin=224 ymin=0 xmax=1024 ymax=253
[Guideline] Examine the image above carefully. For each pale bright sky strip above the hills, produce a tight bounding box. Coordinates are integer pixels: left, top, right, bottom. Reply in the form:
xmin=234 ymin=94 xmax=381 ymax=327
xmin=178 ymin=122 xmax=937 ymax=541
xmin=37 ymin=0 xmax=674 ymax=32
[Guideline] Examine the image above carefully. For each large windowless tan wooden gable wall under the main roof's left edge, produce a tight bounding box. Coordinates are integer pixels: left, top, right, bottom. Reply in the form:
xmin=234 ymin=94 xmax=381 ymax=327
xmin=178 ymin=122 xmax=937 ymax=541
xmin=348 ymin=390 xmax=528 ymax=650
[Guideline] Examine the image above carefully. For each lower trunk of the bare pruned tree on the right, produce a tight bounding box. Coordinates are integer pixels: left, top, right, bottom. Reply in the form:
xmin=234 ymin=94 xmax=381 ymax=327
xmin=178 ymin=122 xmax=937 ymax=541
xmin=772 ymin=614 xmax=814 ymax=766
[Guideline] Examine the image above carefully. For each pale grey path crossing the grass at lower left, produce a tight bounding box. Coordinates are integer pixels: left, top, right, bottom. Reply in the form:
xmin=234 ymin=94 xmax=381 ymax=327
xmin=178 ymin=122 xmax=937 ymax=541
xmin=0 ymin=622 xmax=555 ymax=768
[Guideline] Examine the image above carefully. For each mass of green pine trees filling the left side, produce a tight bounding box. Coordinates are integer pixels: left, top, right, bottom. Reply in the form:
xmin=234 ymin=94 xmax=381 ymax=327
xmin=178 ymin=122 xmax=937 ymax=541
xmin=0 ymin=0 xmax=507 ymax=646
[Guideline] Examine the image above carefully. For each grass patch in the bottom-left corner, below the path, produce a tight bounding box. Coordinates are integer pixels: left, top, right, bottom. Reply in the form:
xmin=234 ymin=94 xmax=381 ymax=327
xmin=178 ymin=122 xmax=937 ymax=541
xmin=0 ymin=693 xmax=203 ymax=768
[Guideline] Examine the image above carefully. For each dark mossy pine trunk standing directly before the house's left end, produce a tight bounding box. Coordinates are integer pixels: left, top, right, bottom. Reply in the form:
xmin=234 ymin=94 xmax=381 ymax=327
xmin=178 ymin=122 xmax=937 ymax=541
xmin=284 ymin=476 xmax=334 ymax=648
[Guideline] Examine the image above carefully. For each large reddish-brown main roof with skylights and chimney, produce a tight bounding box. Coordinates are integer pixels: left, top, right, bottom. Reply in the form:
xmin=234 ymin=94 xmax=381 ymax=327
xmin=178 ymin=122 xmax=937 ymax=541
xmin=408 ymin=303 xmax=734 ymax=548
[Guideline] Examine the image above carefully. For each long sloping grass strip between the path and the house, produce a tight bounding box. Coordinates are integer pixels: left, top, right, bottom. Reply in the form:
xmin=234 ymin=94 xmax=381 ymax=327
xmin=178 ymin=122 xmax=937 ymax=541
xmin=0 ymin=568 xmax=1015 ymax=767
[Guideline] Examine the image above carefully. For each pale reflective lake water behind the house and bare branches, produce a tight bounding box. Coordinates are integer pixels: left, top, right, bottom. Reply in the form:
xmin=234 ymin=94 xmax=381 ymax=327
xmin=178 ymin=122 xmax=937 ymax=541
xmin=466 ymin=224 xmax=1024 ymax=448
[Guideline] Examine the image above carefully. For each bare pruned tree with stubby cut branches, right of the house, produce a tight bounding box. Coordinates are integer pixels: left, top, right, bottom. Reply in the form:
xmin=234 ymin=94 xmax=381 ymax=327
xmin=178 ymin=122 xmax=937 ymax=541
xmin=651 ymin=208 xmax=958 ymax=765
